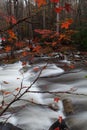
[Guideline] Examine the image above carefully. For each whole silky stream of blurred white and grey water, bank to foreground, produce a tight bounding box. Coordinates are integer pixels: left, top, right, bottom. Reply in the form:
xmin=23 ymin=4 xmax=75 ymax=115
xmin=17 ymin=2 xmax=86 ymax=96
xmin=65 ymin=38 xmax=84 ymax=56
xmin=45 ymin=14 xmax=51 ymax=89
xmin=0 ymin=63 xmax=87 ymax=130
